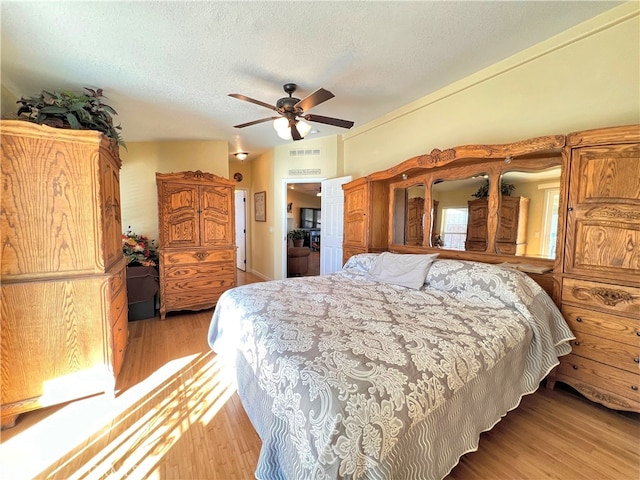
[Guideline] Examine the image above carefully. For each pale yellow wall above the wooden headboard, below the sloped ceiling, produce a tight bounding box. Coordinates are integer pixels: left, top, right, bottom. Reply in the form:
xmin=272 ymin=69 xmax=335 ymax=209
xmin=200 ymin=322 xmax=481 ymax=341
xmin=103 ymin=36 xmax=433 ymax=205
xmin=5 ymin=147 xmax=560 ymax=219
xmin=344 ymin=2 xmax=640 ymax=178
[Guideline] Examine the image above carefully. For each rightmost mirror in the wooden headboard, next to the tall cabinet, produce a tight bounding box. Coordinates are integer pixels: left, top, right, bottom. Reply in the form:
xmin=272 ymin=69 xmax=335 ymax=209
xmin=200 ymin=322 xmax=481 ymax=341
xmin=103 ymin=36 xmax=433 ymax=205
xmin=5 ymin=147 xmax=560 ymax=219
xmin=496 ymin=166 xmax=560 ymax=258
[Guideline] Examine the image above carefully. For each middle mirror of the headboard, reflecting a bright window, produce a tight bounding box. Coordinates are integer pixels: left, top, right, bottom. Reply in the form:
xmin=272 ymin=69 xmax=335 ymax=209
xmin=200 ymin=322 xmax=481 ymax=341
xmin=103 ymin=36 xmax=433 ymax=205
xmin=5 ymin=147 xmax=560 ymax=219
xmin=431 ymin=173 xmax=489 ymax=251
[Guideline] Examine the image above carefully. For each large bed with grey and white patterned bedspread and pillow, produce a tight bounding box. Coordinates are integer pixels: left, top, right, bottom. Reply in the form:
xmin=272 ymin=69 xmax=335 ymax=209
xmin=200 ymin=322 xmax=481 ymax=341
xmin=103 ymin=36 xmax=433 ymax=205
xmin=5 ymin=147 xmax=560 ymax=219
xmin=209 ymin=252 xmax=574 ymax=480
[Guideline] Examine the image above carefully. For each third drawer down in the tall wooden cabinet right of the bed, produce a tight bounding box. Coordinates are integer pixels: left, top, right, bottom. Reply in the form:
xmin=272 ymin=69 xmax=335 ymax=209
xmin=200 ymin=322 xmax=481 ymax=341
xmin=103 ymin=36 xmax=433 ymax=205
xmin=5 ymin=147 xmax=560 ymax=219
xmin=571 ymin=332 xmax=640 ymax=374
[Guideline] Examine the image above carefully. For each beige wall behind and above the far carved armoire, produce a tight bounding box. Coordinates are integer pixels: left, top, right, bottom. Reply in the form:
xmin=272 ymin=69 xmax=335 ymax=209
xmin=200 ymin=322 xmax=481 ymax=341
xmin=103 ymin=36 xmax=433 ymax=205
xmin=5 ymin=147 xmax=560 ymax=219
xmin=120 ymin=141 xmax=229 ymax=244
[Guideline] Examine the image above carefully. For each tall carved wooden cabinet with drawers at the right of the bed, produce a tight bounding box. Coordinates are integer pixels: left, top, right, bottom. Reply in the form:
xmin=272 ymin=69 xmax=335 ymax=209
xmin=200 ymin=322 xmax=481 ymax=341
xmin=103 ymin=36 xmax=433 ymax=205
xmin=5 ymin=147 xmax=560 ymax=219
xmin=551 ymin=125 xmax=640 ymax=412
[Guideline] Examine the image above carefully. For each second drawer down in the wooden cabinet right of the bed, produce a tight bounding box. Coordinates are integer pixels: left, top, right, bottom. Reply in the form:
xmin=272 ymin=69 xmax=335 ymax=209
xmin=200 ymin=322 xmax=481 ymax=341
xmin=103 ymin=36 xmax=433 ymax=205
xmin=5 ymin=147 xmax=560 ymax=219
xmin=562 ymin=305 xmax=640 ymax=349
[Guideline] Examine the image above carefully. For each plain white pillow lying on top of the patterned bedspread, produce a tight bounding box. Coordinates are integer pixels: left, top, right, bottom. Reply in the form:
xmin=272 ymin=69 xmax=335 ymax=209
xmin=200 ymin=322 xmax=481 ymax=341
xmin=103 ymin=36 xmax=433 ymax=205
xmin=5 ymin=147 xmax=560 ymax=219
xmin=366 ymin=252 xmax=438 ymax=290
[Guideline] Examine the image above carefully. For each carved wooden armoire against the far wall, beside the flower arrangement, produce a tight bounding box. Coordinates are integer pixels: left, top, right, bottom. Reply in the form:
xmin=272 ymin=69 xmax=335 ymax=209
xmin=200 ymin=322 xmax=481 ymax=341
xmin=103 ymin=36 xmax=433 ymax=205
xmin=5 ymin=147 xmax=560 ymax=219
xmin=156 ymin=171 xmax=236 ymax=319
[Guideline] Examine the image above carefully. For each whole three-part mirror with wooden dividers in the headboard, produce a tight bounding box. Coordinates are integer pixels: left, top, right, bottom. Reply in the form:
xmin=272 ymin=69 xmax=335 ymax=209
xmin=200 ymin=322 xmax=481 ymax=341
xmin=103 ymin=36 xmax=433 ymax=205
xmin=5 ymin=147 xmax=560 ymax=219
xmin=390 ymin=154 xmax=562 ymax=259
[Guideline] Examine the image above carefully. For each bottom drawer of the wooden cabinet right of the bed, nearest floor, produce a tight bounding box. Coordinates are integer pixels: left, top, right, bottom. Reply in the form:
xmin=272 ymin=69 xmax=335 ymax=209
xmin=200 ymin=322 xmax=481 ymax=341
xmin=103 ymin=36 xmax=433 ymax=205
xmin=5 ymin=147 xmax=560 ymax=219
xmin=558 ymin=353 xmax=640 ymax=409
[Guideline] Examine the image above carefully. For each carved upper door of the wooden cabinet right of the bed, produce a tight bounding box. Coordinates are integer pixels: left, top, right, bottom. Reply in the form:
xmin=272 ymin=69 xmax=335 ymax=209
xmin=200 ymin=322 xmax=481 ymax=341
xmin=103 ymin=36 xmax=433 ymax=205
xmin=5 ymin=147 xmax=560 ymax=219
xmin=564 ymin=144 xmax=640 ymax=281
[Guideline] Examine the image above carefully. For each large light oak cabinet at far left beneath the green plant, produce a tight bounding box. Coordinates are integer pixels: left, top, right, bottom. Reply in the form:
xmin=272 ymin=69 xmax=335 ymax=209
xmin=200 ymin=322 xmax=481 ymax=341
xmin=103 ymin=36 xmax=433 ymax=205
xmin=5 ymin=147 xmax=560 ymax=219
xmin=0 ymin=120 xmax=128 ymax=427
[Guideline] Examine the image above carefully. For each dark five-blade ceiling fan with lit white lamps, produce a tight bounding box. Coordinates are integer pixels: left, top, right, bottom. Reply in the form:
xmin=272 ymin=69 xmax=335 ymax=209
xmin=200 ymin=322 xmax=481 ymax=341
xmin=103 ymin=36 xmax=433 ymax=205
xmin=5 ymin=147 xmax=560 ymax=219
xmin=229 ymin=83 xmax=353 ymax=140
